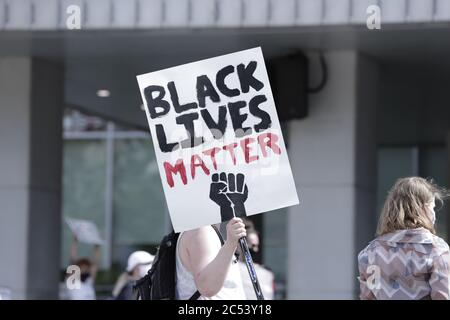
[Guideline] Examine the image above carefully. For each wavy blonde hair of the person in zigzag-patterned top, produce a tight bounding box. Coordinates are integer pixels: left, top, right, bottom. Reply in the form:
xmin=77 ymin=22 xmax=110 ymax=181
xmin=377 ymin=177 xmax=449 ymax=235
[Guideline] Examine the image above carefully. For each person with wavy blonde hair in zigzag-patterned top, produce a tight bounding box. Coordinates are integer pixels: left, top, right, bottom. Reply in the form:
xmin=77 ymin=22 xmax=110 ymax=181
xmin=358 ymin=177 xmax=450 ymax=300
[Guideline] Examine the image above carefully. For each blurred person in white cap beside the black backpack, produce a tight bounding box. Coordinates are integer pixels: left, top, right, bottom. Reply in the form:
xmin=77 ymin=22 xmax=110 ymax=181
xmin=112 ymin=251 xmax=155 ymax=300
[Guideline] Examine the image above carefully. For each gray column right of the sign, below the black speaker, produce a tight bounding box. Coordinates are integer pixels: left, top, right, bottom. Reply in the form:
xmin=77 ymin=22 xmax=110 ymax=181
xmin=287 ymin=51 xmax=378 ymax=299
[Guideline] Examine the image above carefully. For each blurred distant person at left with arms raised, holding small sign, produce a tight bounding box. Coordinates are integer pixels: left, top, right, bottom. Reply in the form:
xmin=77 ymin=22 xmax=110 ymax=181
xmin=67 ymin=235 xmax=100 ymax=300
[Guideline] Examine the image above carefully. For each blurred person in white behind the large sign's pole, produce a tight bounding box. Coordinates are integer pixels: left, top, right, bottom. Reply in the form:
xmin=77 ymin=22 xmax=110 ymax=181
xmin=239 ymin=219 xmax=275 ymax=300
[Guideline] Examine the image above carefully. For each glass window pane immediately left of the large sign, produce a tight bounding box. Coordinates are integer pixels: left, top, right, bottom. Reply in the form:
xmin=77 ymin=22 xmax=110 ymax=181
xmin=113 ymin=139 xmax=168 ymax=261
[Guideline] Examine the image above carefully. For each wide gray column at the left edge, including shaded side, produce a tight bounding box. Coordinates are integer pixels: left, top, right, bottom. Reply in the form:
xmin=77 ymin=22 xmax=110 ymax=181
xmin=0 ymin=57 xmax=64 ymax=299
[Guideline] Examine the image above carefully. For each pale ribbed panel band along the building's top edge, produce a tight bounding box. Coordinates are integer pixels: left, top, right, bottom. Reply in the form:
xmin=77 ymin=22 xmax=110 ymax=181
xmin=0 ymin=0 xmax=450 ymax=30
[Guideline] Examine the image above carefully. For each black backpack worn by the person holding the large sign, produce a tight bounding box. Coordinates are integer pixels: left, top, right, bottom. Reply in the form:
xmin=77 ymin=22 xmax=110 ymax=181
xmin=133 ymin=226 xmax=224 ymax=300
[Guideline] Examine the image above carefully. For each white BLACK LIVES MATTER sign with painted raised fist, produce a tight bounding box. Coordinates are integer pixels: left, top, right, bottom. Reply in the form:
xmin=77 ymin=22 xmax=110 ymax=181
xmin=137 ymin=48 xmax=298 ymax=232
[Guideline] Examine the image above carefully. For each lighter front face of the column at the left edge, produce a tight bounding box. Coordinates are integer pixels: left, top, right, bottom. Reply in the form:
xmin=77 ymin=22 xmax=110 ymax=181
xmin=0 ymin=58 xmax=31 ymax=298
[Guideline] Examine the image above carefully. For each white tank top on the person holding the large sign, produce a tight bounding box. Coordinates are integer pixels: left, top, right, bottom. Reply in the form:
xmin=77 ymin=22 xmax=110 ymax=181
xmin=176 ymin=229 xmax=246 ymax=300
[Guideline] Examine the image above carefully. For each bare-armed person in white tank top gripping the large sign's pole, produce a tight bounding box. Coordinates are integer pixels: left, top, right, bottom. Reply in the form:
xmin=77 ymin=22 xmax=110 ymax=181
xmin=176 ymin=218 xmax=247 ymax=300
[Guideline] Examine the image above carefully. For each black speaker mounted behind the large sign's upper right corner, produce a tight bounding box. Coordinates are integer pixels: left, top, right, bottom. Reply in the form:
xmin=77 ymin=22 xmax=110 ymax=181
xmin=267 ymin=52 xmax=308 ymax=121
